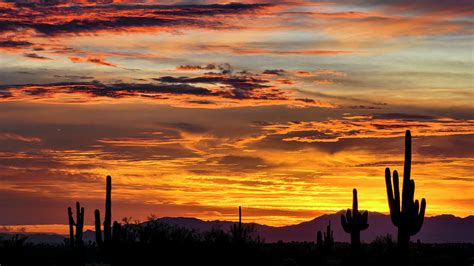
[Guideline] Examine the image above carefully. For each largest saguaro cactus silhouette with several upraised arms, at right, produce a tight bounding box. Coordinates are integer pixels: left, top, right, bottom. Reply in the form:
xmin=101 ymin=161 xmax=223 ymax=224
xmin=385 ymin=130 xmax=426 ymax=251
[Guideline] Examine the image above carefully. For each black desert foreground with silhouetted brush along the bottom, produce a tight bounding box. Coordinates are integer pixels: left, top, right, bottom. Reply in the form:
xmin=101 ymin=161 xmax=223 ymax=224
xmin=0 ymin=223 xmax=474 ymax=266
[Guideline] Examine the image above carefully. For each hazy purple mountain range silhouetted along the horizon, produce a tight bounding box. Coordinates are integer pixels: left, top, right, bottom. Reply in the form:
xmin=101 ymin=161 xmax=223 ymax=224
xmin=4 ymin=211 xmax=474 ymax=244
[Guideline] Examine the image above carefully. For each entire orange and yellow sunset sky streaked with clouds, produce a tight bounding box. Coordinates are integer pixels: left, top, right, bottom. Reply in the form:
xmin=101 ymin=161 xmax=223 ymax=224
xmin=0 ymin=0 xmax=474 ymax=231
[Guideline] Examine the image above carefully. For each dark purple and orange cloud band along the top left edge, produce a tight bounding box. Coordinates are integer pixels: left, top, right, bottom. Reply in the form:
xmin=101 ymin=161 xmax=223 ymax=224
xmin=0 ymin=3 xmax=270 ymax=35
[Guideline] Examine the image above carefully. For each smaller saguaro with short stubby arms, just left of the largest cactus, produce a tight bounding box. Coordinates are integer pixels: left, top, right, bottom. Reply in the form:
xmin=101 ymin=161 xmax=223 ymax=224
xmin=341 ymin=188 xmax=369 ymax=250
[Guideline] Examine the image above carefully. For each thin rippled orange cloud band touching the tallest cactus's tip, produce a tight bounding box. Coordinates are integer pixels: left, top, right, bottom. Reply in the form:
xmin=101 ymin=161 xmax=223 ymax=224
xmin=263 ymin=113 xmax=474 ymax=143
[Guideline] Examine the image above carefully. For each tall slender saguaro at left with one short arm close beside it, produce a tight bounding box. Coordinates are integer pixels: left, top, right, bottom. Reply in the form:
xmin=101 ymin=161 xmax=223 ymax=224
xmin=94 ymin=176 xmax=120 ymax=246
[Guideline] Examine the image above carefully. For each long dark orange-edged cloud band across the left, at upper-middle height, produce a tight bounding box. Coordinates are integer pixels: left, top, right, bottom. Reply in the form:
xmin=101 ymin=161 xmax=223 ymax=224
xmin=0 ymin=75 xmax=332 ymax=108
